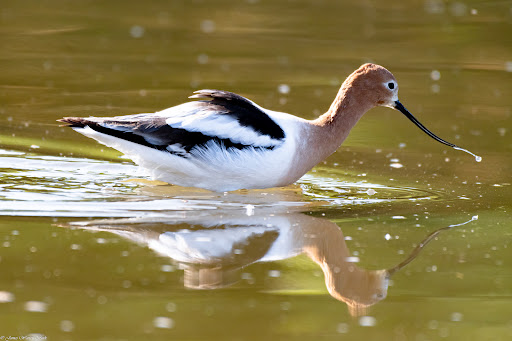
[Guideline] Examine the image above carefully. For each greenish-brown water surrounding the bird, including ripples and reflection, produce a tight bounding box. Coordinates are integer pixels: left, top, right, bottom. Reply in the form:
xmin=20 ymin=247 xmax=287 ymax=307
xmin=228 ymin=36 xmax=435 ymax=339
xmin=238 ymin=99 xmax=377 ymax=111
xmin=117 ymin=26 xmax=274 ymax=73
xmin=0 ymin=0 xmax=512 ymax=340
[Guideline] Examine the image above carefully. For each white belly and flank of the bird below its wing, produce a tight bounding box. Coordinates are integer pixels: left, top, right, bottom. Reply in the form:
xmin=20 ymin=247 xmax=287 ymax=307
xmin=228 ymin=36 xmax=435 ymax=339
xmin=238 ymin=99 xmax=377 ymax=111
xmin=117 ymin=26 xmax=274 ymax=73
xmin=74 ymin=127 xmax=295 ymax=192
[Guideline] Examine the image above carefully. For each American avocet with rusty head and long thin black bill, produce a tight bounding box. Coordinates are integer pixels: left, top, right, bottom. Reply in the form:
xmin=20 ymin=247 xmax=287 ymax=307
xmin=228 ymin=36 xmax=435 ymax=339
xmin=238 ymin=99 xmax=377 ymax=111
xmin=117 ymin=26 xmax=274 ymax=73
xmin=59 ymin=64 xmax=481 ymax=192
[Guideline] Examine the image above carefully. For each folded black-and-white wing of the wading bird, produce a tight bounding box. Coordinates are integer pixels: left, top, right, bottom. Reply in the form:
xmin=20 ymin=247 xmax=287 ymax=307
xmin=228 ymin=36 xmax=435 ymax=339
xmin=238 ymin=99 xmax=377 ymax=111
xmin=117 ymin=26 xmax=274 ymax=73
xmin=59 ymin=90 xmax=285 ymax=157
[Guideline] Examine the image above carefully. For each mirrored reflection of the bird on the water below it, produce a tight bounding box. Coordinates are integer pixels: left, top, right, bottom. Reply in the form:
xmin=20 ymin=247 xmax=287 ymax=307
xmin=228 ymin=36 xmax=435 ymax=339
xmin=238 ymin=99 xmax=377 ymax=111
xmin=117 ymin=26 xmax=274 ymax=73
xmin=64 ymin=212 xmax=476 ymax=316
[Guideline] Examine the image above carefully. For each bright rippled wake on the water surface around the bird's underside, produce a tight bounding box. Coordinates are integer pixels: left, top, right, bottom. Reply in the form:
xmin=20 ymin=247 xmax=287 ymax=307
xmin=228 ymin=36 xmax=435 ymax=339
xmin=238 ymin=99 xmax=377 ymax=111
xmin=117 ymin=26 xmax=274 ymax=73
xmin=0 ymin=150 xmax=437 ymax=217
